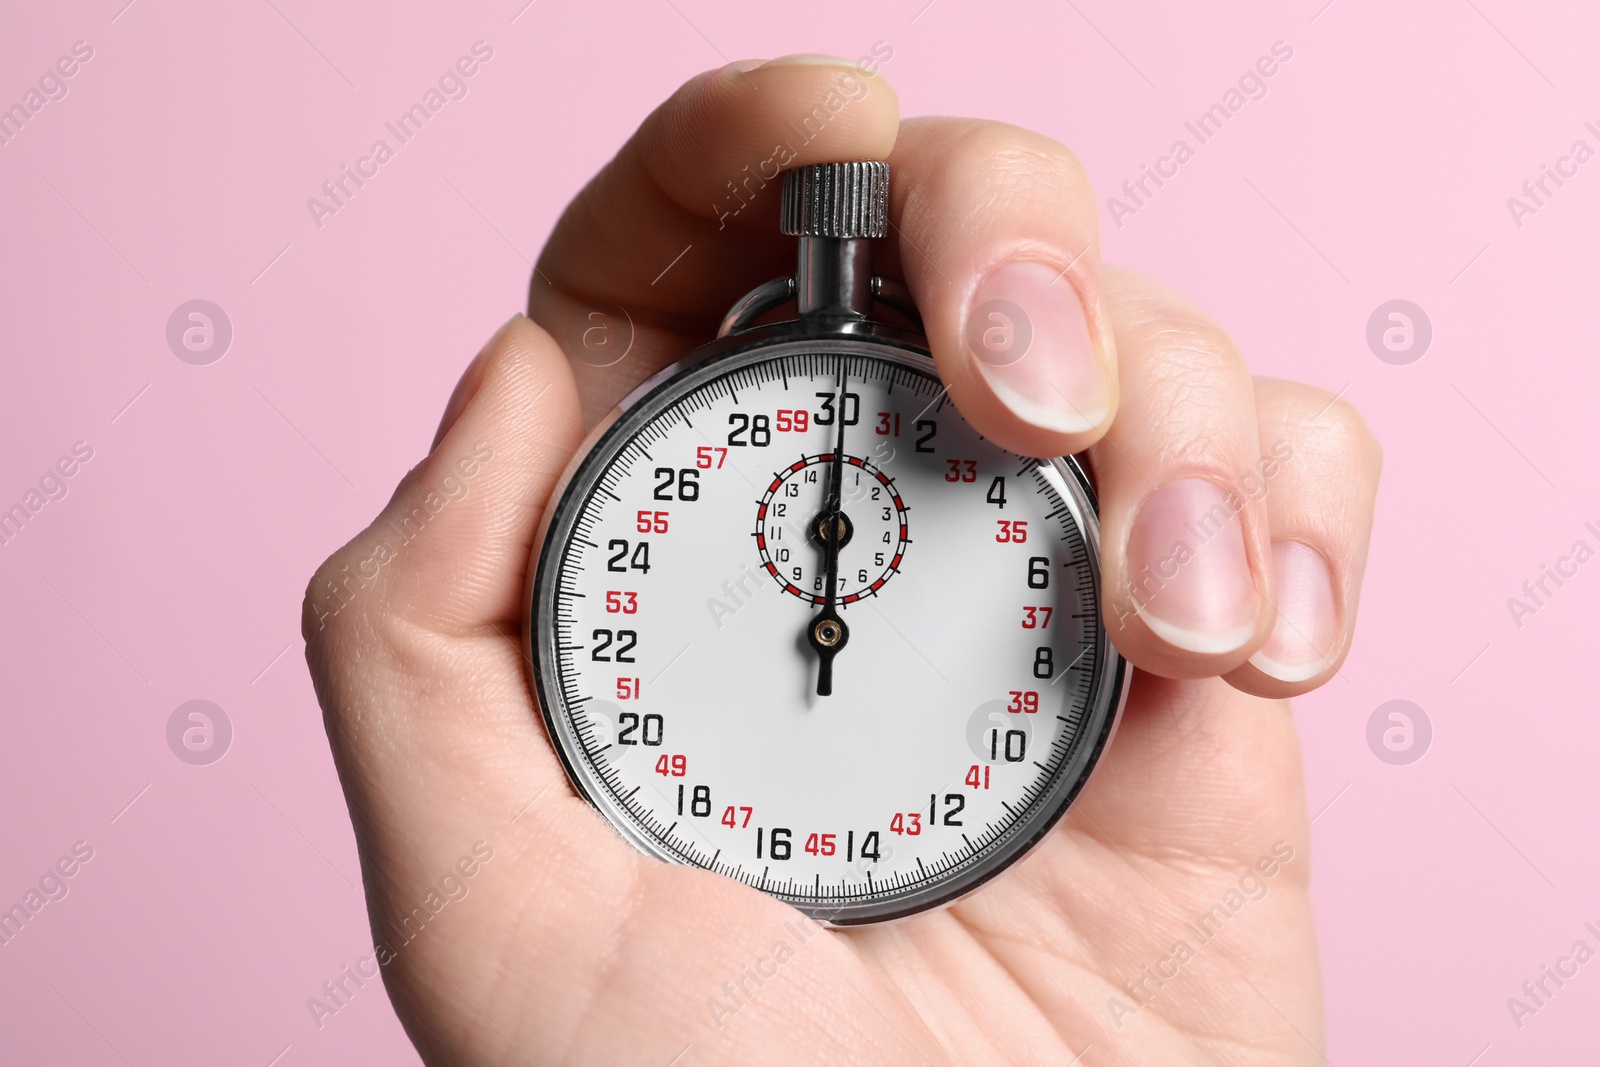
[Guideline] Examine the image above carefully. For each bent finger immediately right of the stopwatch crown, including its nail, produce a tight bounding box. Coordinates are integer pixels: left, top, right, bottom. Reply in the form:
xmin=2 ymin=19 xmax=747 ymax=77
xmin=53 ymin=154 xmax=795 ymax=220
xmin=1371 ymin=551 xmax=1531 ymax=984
xmin=890 ymin=118 xmax=1117 ymax=456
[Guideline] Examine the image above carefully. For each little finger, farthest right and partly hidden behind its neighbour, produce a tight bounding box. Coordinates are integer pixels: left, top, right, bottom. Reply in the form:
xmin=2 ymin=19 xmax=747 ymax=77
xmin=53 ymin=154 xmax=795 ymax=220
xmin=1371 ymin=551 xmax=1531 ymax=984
xmin=1227 ymin=378 xmax=1382 ymax=696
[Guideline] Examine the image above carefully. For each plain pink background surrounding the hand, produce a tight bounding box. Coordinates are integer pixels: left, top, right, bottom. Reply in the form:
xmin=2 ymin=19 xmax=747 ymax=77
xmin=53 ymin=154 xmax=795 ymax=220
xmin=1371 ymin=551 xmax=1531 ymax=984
xmin=0 ymin=0 xmax=1600 ymax=1067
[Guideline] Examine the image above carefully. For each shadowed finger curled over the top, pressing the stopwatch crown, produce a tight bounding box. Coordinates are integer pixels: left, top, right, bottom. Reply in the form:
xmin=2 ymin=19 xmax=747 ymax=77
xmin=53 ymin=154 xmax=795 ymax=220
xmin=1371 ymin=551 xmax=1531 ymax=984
xmin=528 ymin=53 xmax=899 ymax=422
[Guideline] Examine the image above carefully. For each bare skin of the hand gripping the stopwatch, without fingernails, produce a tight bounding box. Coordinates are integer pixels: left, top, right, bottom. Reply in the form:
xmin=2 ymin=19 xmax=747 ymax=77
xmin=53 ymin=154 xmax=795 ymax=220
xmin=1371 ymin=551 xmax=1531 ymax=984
xmin=304 ymin=58 xmax=1381 ymax=1067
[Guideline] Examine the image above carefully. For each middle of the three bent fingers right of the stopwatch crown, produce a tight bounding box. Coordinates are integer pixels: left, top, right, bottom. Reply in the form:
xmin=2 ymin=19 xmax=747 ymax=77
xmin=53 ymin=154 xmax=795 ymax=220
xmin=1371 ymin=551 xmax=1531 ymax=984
xmin=1091 ymin=269 xmax=1274 ymax=678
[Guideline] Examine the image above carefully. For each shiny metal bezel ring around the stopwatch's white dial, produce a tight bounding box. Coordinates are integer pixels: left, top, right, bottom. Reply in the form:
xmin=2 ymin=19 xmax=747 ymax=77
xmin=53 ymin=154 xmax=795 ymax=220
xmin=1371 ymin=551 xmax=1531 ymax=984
xmin=523 ymin=320 xmax=1130 ymax=926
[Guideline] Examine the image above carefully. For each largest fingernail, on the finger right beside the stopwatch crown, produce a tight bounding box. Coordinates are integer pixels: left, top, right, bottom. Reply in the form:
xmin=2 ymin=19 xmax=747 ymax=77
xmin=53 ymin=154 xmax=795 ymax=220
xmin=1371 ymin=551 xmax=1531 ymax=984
xmin=965 ymin=261 xmax=1110 ymax=434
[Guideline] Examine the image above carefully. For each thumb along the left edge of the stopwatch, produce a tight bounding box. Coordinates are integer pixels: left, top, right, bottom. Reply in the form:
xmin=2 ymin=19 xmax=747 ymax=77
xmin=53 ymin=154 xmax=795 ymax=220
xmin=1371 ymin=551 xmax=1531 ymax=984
xmin=301 ymin=308 xmax=582 ymax=854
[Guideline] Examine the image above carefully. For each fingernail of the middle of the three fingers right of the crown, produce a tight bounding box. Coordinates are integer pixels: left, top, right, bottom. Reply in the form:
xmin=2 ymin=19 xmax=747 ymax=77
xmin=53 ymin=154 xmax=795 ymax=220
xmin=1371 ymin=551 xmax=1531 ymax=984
xmin=1126 ymin=478 xmax=1258 ymax=656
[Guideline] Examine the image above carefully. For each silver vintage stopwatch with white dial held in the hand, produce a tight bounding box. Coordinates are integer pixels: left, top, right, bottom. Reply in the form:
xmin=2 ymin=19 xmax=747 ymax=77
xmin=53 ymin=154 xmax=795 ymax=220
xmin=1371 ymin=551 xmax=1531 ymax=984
xmin=523 ymin=163 xmax=1128 ymax=926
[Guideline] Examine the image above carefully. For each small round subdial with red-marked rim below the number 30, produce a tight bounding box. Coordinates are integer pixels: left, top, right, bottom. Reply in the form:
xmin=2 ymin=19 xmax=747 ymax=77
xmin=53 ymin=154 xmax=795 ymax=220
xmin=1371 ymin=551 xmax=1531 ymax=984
xmin=755 ymin=453 xmax=910 ymax=605
